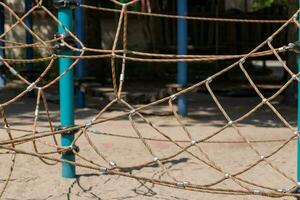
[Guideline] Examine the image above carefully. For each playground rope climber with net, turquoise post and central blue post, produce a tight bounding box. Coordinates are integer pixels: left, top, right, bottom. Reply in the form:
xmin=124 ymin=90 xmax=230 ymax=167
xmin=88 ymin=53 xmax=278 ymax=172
xmin=0 ymin=0 xmax=300 ymax=198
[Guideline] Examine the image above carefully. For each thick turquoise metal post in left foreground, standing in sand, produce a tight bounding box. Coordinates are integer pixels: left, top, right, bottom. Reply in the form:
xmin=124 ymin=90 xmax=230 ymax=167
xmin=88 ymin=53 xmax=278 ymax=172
xmin=58 ymin=8 xmax=76 ymax=178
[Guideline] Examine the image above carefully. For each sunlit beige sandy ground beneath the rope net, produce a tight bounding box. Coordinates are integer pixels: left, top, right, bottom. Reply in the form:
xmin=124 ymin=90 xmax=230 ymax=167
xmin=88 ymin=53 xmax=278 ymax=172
xmin=0 ymin=85 xmax=296 ymax=200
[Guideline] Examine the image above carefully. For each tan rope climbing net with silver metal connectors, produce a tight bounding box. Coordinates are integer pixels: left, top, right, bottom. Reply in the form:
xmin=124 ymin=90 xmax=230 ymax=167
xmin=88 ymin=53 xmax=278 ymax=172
xmin=0 ymin=0 xmax=300 ymax=198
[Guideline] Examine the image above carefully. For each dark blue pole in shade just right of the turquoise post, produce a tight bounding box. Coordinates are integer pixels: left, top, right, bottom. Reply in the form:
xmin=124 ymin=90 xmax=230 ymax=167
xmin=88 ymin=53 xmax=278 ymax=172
xmin=75 ymin=0 xmax=86 ymax=108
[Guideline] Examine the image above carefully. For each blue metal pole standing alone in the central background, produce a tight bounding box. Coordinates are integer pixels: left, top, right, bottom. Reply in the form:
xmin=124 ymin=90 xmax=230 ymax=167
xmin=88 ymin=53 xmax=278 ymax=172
xmin=177 ymin=0 xmax=187 ymax=116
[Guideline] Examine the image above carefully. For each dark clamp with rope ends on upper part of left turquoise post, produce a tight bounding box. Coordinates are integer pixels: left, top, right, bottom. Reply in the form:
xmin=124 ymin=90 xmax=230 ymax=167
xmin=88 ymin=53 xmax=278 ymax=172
xmin=53 ymin=33 xmax=77 ymax=52
